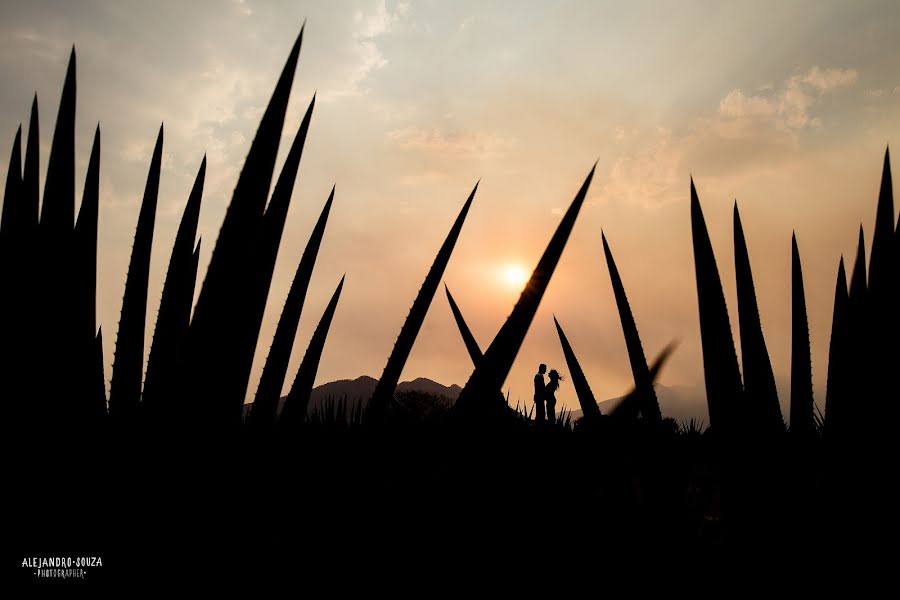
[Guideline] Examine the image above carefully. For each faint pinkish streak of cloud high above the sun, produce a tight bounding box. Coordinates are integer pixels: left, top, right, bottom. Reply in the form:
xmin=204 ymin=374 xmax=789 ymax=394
xmin=387 ymin=127 xmax=515 ymax=159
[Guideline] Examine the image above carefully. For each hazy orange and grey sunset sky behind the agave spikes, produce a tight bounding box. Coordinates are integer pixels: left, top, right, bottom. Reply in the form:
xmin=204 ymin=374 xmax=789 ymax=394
xmin=0 ymin=0 xmax=900 ymax=417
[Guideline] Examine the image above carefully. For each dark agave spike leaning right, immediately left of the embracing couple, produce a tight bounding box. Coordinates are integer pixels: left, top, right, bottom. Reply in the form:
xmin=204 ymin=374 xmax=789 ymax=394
xmin=455 ymin=164 xmax=597 ymax=411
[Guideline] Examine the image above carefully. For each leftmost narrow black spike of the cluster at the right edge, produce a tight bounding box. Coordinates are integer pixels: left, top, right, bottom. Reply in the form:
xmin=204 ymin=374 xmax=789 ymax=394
xmin=825 ymin=257 xmax=850 ymax=435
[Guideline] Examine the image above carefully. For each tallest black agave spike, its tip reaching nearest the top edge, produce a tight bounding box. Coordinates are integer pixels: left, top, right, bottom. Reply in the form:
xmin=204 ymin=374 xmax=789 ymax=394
xmin=181 ymin=28 xmax=303 ymax=427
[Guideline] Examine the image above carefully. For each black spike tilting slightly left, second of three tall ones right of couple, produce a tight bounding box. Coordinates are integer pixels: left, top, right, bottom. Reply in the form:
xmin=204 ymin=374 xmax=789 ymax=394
xmin=734 ymin=202 xmax=784 ymax=433
